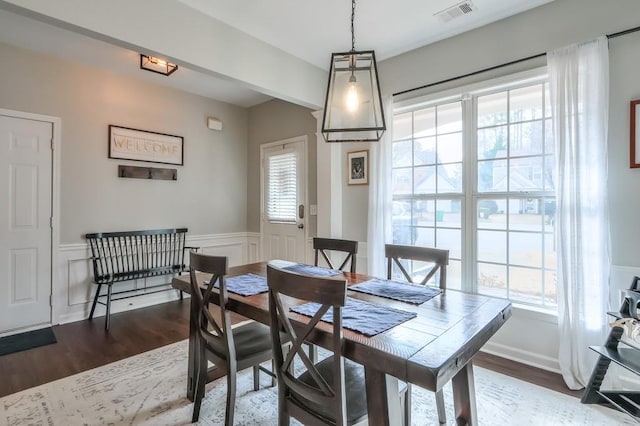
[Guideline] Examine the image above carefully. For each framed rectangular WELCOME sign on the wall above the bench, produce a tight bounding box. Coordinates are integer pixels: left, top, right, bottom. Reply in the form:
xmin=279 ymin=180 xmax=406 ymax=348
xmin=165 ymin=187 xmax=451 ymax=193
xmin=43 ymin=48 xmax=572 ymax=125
xmin=109 ymin=125 xmax=184 ymax=166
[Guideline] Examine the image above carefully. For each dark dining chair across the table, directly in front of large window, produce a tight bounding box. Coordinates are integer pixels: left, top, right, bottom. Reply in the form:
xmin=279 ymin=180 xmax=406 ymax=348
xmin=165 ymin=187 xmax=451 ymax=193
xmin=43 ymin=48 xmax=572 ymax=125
xmin=384 ymin=244 xmax=449 ymax=425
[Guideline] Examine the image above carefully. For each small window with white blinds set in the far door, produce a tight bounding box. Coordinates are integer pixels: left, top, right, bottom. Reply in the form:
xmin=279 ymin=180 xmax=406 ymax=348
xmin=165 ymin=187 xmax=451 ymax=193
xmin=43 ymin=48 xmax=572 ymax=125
xmin=265 ymin=150 xmax=298 ymax=223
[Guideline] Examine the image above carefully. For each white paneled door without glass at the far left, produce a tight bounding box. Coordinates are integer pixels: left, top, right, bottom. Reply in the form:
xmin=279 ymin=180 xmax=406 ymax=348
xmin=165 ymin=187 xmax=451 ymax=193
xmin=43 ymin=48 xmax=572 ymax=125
xmin=0 ymin=115 xmax=53 ymax=334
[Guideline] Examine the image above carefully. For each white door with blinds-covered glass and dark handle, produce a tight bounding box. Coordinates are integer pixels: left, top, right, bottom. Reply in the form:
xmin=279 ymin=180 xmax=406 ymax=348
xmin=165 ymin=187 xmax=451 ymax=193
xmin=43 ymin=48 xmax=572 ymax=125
xmin=260 ymin=136 xmax=307 ymax=262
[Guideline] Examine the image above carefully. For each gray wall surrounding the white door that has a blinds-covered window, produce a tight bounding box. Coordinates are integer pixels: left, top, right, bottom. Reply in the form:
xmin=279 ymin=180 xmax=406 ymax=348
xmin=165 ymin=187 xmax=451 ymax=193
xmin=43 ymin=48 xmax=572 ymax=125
xmin=246 ymin=99 xmax=317 ymax=237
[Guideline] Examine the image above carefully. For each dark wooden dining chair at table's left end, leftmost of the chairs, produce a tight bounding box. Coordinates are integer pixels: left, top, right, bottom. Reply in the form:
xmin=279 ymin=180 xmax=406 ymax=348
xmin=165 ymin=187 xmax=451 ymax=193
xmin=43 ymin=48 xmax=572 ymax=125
xmin=189 ymin=252 xmax=275 ymax=426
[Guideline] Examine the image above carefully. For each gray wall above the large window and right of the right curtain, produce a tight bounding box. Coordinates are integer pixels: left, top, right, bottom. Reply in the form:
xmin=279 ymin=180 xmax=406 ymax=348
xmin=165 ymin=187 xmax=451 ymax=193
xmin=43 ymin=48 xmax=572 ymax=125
xmin=376 ymin=0 xmax=640 ymax=266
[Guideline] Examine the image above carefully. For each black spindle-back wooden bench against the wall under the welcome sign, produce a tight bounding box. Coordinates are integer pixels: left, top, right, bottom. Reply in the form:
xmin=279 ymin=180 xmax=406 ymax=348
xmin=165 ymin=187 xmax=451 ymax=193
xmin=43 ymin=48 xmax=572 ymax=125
xmin=85 ymin=228 xmax=197 ymax=330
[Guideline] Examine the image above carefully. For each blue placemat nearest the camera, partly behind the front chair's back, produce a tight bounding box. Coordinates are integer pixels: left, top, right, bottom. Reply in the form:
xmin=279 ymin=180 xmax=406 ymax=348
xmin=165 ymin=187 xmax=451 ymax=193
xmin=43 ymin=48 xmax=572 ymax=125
xmin=290 ymin=297 xmax=417 ymax=337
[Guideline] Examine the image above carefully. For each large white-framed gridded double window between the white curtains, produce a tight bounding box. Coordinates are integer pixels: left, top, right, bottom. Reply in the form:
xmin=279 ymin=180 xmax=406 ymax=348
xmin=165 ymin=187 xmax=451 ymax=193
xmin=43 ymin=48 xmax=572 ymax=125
xmin=392 ymin=70 xmax=556 ymax=309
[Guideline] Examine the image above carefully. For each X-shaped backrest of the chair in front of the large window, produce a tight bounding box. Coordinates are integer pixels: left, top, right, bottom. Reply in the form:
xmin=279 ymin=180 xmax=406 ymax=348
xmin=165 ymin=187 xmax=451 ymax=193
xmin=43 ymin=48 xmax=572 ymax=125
xmin=385 ymin=244 xmax=449 ymax=290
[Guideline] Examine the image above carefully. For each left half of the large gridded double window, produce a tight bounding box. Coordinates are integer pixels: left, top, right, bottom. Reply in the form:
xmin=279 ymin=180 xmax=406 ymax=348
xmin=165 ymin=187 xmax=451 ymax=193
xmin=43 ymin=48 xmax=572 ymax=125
xmin=392 ymin=101 xmax=463 ymax=282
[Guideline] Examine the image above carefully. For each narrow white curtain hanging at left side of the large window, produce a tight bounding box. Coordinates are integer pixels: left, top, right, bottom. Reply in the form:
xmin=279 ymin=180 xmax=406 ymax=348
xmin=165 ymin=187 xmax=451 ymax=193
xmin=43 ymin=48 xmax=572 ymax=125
xmin=367 ymin=96 xmax=393 ymax=278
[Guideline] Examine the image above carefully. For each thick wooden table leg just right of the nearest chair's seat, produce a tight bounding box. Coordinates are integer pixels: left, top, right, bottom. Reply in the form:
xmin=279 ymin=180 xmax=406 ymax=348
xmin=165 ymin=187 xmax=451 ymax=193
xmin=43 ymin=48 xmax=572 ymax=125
xmin=364 ymin=367 xmax=402 ymax=426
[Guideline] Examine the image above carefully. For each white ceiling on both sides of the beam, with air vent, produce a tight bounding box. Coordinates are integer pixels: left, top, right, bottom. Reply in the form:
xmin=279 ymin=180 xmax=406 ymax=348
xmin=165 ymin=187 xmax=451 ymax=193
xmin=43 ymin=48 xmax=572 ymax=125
xmin=0 ymin=0 xmax=552 ymax=107
